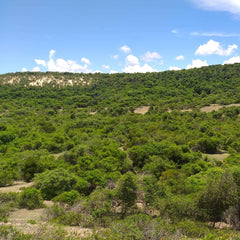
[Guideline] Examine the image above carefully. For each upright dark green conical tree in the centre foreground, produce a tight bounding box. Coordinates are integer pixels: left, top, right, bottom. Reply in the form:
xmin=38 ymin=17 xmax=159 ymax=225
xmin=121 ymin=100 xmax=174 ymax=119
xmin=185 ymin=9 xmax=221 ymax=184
xmin=117 ymin=172 xmax=137 ymax=217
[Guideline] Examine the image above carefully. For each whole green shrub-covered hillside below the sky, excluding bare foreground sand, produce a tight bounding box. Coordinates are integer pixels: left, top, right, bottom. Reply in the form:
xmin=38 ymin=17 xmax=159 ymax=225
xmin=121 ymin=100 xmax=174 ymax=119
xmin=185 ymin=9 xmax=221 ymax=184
xmin=0 ymin=64 xmax=240 ymax=239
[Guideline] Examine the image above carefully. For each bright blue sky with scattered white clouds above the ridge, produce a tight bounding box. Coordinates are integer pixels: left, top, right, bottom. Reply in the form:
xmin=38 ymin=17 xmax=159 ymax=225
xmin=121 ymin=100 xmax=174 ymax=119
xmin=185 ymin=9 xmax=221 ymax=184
xmin=0 ymin=0 xmax=240 ymax=74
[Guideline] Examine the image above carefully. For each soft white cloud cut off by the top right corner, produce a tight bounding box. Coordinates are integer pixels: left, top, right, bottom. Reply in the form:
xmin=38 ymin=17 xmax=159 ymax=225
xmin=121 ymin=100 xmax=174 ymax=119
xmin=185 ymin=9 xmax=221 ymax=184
xmin=191 ymin=0 xmax=240 ymax=14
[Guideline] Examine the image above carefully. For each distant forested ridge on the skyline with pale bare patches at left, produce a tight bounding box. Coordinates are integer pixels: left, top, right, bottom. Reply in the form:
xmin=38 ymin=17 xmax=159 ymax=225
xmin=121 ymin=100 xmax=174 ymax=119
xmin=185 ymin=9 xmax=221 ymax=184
xmin=0 ymin=64 xmax=240 ymax=109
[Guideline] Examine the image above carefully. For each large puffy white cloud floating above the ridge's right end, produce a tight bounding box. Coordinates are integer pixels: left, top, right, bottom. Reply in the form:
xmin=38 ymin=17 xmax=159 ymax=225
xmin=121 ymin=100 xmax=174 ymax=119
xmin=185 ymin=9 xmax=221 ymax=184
xmin=195 ymin=40 xmax=238 ymax=56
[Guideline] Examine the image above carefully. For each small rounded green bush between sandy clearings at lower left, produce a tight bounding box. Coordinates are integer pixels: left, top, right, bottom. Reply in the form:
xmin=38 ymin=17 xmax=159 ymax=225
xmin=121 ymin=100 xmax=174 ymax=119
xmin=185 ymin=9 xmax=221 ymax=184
xmin=19 ymin=188 xmax=43 ymax=209
